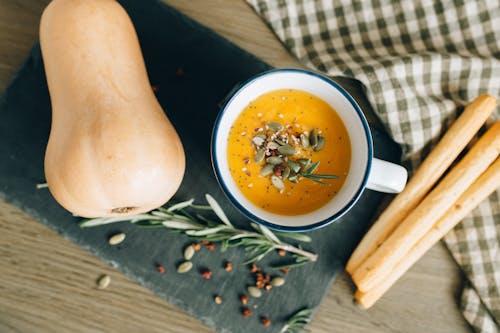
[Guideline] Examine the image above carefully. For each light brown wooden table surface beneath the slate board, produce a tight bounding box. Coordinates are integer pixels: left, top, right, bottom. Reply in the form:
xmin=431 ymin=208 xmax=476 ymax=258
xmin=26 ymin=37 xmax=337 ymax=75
xmin=0 ymin=0 xmax=470 ymax=333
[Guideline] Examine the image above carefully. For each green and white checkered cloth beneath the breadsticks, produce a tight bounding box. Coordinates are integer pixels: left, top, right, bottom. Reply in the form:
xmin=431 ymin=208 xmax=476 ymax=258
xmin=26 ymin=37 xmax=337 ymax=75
xmin=247 ymin=0 xmax=500 ymax=332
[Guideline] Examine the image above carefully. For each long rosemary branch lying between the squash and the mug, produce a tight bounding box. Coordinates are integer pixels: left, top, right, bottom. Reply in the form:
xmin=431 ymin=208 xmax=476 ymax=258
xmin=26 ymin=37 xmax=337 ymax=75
xmin=80 ymin=194 xmax=318 ymax=267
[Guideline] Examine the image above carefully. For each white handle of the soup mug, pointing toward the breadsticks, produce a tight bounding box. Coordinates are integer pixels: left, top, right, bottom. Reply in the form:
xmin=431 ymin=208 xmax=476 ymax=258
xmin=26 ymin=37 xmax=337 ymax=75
xmin=366 ymin=158 xmax=408 ymax=193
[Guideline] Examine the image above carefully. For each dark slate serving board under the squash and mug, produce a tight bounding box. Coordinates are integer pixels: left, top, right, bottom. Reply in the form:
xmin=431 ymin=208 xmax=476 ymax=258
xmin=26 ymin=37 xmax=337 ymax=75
xmin=0 ymin=0 xmax=400 ymax=332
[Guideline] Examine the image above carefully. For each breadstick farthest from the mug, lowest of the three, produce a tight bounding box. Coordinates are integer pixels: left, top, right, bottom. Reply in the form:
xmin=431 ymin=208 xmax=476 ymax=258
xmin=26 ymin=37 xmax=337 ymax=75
xmin=354 ymin=158 xmax=500 ymax=309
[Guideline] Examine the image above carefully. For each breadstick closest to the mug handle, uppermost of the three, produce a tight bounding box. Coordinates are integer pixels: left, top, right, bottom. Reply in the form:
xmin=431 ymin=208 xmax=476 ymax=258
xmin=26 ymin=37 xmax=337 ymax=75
xmin=346 ymin=94 xmax=497 ymax=274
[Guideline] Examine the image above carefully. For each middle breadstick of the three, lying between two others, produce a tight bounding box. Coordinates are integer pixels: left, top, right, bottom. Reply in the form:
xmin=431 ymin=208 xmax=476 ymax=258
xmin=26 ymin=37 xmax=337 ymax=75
xmin=352 ymin=121 xmax=500 ymax=292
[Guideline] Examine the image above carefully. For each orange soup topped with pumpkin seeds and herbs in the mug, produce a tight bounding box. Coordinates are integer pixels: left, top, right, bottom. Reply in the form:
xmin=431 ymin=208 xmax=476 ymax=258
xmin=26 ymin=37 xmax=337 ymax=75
xmin=227 ymin=89 xmax=351 ymax=215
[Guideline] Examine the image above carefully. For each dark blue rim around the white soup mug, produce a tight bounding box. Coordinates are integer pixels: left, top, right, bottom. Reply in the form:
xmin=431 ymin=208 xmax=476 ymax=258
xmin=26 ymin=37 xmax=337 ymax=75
xmin=210 ymin=68 xmax=373 ymax=232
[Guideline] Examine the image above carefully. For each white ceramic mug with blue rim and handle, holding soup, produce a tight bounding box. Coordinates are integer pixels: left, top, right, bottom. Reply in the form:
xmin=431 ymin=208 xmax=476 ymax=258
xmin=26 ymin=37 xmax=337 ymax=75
xmin=211 ymin=69 xmax=407 ymax=231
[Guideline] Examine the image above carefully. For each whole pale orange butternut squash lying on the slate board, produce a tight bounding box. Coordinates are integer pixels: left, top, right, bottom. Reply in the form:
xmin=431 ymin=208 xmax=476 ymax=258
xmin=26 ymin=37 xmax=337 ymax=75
xmin=40 ymin=0 xmax=185 ymax=218
